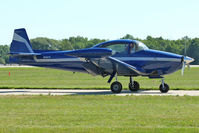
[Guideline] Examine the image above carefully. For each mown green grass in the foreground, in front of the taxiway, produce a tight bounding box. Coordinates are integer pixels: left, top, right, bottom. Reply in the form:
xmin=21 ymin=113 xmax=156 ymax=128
xmin=0 ymin=95 xmax=199 ymax=133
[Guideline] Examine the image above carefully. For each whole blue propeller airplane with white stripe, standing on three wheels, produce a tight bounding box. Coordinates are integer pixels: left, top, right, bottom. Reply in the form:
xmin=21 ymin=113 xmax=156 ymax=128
xmin=10 ymin=29 xmax=194 ymax=93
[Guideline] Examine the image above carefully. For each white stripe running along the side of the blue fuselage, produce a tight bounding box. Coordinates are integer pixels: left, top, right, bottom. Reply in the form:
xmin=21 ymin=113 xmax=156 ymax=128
xmin=34 ymin=57 xmax=181 ymax=62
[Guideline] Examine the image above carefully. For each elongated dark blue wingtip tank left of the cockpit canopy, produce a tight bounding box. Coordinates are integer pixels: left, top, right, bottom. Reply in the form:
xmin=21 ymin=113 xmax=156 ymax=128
xmin=65 ymin=48 xmax=112 ymax=58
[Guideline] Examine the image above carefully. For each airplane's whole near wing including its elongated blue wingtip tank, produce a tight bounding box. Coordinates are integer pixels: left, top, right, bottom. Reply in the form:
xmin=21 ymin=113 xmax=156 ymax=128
xmin=62 ymin=48 xmax=142 ymax=76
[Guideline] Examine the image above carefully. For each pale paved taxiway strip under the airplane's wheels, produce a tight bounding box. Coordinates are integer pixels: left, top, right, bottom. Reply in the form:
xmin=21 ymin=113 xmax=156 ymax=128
xmin=0 ymin=89 xmax=199 ymax=96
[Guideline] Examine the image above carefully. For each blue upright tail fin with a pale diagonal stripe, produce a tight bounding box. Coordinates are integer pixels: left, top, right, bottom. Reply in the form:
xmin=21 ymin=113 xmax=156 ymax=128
xmin=10 ymin=29 xmax=34 ymax=54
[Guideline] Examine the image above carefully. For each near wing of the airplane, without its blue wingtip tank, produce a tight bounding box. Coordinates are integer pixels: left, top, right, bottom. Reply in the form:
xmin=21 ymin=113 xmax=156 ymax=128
xmin=83 ymin=56 xmax=142 ymax=76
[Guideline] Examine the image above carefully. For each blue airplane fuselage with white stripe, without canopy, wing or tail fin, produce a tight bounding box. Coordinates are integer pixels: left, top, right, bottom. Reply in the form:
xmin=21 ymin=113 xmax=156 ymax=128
xmin=10 ymin=49 xmax=182 ymax=76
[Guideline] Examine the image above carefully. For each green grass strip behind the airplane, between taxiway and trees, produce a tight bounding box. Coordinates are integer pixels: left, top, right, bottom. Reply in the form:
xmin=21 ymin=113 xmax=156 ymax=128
xmin=0 ymin=68 xmax=199 ymax=89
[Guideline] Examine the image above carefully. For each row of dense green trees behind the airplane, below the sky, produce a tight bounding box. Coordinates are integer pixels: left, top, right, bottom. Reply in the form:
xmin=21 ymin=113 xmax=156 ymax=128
xmin=0 ymin=34 xmax=199 ymax=64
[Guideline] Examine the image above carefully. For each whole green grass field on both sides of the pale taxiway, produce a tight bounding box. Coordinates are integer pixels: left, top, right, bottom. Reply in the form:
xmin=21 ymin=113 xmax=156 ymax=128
xmin=0 ymin=68 xmax=199 ymax=133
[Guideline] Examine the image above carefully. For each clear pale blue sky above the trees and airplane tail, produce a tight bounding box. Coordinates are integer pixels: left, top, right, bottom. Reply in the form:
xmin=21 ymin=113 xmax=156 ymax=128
xmin=0 ymin=0 xmax=199 ymax=45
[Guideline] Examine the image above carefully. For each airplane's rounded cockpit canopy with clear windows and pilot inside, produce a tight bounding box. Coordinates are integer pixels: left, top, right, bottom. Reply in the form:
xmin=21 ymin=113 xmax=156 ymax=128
xmin=94 ymin=39 xmax=149 ymax=54
